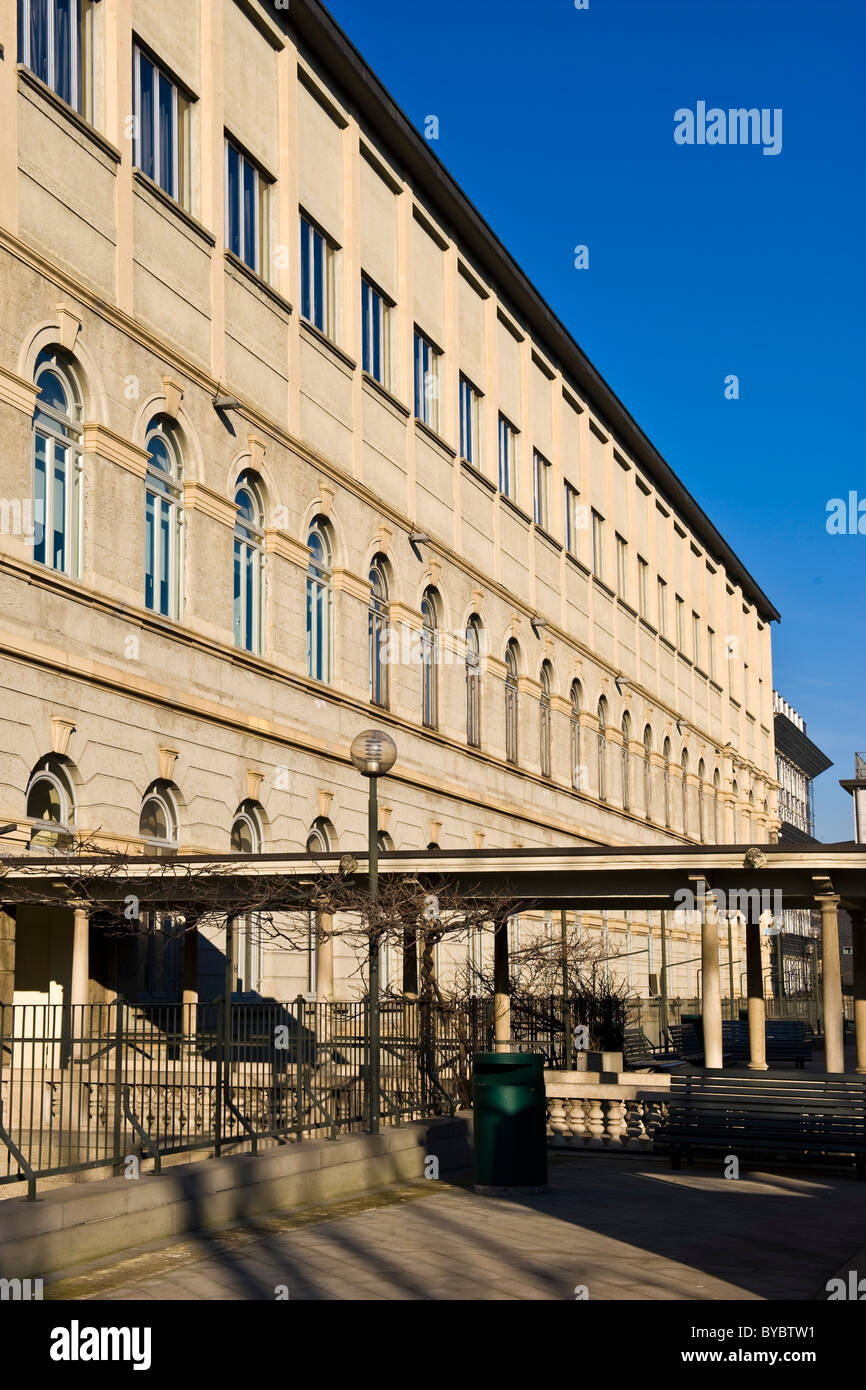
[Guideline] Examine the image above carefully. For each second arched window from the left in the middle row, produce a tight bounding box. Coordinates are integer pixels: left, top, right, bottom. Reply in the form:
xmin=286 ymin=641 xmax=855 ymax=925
xmin=145 ymin=416 xmax=183 ymax=619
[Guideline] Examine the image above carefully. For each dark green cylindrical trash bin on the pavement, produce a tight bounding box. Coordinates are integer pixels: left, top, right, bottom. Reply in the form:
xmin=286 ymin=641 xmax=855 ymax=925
xmin=473 ymin=1052 xmax=548 ymax=1194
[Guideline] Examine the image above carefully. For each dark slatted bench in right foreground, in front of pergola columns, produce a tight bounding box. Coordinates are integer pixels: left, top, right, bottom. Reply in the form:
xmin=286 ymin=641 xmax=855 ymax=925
xmin=653 ymin=1069 xmax=866 ymax=1179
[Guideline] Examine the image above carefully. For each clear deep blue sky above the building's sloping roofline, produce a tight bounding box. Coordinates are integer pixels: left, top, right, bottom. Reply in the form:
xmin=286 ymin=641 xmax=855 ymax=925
xmin=329 ymin=0 xmax=866 ymax=841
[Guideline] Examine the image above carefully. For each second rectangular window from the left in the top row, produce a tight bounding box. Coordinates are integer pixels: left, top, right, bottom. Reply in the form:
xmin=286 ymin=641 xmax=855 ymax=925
xmin=132 ymin=43 xmax=190 ymax=207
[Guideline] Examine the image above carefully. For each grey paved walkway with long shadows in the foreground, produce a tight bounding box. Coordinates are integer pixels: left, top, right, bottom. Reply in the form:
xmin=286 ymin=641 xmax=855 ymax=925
xmin=46 ymin=1154 xmax=866 ymax=1300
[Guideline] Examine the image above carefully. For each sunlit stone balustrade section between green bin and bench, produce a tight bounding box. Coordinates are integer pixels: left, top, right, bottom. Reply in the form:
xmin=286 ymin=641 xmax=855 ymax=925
xmin=545 ymin=1072 xmax=670 ymax=1154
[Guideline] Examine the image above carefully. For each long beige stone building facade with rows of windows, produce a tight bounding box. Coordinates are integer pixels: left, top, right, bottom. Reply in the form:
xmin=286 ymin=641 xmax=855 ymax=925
xmin=0 ymin=0 xmax=778 ymax=1001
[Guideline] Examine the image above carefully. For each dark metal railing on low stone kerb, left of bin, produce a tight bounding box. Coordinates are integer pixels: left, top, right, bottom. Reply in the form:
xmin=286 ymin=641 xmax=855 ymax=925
xmin=0 ymin=998 xmax=471 ymax=1197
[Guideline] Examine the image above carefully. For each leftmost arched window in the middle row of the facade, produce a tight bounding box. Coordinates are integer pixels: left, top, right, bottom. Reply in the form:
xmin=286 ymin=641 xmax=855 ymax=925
xmin=31 ymin=349 xmax=82 ymax=575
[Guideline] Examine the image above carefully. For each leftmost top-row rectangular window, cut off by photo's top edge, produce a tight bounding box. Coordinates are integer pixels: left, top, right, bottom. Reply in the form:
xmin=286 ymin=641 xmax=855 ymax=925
xmin=18 ymin=0 xmax=93 ymax=120
